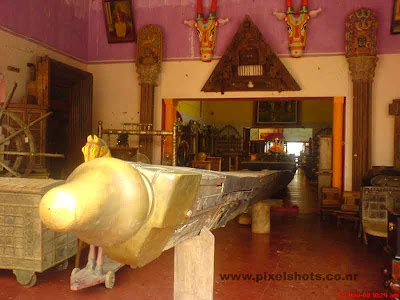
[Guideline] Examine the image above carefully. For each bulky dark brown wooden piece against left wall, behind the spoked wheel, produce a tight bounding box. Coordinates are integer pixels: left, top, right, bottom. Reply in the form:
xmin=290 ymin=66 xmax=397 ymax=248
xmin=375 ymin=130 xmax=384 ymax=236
xmin=11 ymin=56 xmax=93 ymax=178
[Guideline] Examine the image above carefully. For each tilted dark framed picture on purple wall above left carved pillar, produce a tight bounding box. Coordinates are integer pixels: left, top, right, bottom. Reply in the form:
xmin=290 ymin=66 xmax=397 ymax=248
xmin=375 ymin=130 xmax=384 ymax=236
xmin=103 ymin=0 xmax=137 ymax=43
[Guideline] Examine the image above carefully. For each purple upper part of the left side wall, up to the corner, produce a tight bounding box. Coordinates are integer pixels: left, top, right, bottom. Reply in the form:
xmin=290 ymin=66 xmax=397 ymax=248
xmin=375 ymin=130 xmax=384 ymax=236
xmin=0 ymin=0 xmax=89 ymax=61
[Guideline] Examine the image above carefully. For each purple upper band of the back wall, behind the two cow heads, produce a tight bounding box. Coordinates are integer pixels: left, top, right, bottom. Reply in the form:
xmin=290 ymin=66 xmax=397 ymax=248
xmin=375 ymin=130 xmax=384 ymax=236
xmin=89 ymin=0 xmax=400 ymax=61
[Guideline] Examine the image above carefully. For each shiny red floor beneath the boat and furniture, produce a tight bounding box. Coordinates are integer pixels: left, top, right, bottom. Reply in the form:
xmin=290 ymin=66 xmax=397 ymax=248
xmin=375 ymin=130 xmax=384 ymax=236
xmin=0 ymin=170 xmax=385 ymax=300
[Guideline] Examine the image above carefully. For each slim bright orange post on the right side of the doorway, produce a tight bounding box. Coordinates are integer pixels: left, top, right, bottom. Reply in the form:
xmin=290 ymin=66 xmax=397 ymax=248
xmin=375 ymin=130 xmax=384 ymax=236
xmin=332 ymin=97 xmax=344 ymax=195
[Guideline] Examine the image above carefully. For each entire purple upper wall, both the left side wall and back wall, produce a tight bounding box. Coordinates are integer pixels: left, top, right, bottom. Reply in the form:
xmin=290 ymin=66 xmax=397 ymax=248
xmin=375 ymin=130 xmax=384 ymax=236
xmin=0 ymin=0 xmax=400 ymax=62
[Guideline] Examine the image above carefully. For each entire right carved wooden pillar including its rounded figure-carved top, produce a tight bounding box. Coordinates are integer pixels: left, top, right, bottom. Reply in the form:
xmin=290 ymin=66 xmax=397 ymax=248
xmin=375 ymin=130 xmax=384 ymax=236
xmin=346 ymin=8 xmax=378 ymax=191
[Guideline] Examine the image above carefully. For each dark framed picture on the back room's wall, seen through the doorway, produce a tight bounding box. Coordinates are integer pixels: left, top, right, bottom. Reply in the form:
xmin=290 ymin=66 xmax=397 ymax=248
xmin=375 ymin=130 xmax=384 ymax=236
xmin=255 ymin=100 xmax=298 ymax=125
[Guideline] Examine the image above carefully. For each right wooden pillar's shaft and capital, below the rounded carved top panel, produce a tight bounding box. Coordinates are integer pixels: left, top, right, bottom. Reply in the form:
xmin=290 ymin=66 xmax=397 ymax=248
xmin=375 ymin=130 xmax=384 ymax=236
xmin=347 ymin=56 xmax=378 ymax=191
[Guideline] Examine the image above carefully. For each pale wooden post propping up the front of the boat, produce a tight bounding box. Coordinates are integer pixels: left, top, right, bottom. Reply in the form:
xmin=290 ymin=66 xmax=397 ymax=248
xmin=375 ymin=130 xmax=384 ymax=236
xmin=174 ymin=227 xmax=215 ymax=300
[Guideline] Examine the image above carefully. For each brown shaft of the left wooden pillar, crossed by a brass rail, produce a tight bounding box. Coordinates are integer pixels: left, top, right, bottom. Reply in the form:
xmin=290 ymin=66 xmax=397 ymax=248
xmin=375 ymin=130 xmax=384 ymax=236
xmin=139 ymin=83 xmax=154 ymax=161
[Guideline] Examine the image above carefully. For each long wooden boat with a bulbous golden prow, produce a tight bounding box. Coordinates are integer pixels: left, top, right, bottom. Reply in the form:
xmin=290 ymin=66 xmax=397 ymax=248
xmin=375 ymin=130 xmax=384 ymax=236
xmin=39 ymin=158 xmax=293 ymax=267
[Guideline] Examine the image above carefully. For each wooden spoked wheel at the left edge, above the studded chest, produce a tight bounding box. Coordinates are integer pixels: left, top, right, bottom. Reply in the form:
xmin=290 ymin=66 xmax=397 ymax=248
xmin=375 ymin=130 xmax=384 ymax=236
xmin=0 ymin=111 xmax=36 ymax=177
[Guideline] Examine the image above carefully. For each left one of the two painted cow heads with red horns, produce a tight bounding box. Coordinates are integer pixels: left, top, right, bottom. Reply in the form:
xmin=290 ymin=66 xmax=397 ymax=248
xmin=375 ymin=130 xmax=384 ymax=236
xmin=184 ymin=0 xmax=229 ymax=62
